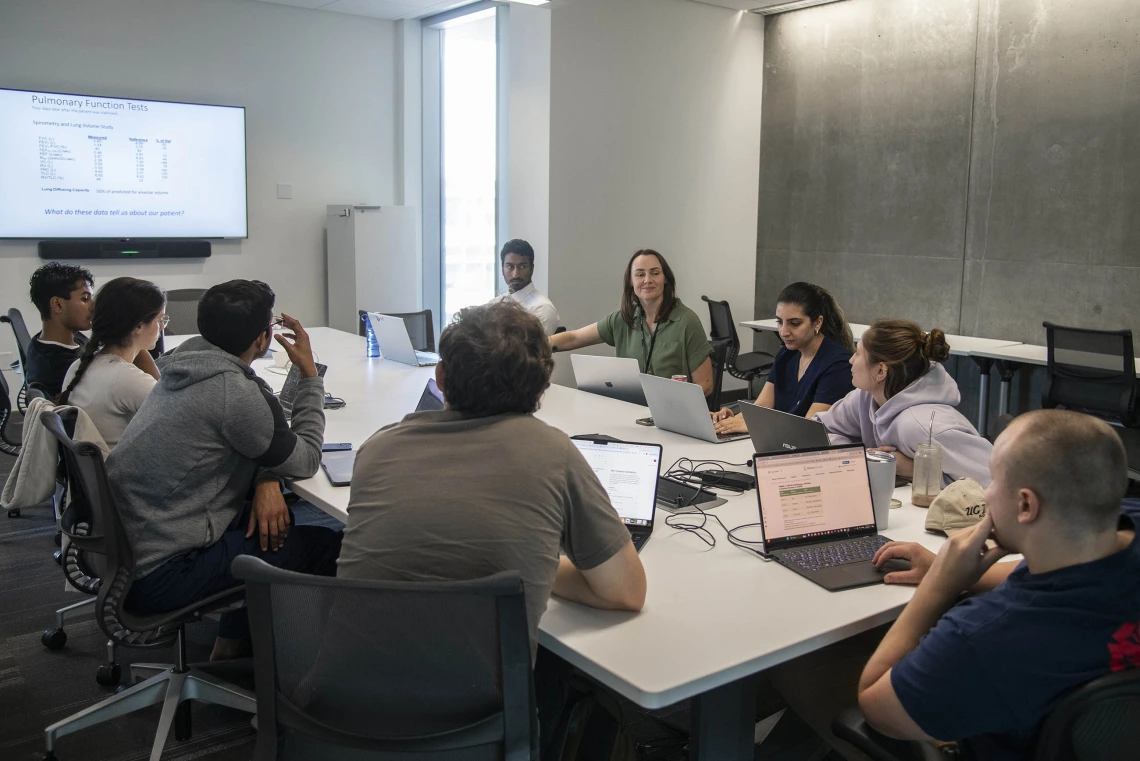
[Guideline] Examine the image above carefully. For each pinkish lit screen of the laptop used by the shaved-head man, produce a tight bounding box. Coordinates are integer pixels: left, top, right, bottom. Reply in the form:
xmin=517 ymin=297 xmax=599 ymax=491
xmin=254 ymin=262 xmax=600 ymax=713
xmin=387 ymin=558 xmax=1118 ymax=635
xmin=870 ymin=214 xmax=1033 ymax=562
xmin=755 ymin=445 xmax=876 ymax=551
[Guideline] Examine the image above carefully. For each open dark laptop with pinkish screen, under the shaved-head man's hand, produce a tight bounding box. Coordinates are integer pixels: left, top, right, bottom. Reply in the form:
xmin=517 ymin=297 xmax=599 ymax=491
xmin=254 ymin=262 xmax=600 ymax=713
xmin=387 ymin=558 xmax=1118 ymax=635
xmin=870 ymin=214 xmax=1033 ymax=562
xmin=754 ymin=444 xmax=909 ymax=590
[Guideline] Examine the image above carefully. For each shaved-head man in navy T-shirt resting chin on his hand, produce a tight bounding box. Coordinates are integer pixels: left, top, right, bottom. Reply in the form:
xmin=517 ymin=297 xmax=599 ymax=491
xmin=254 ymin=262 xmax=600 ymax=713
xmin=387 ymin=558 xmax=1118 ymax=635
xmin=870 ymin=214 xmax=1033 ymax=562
xmin=858 ymin=410 xmax=1140 ymax=761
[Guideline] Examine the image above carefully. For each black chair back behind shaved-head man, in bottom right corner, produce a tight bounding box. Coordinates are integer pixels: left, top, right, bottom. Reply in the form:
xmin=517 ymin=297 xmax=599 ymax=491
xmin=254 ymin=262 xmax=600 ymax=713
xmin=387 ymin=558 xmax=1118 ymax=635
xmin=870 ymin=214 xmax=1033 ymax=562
xmin=1033 ymin=669 xmax=1140 ymax=761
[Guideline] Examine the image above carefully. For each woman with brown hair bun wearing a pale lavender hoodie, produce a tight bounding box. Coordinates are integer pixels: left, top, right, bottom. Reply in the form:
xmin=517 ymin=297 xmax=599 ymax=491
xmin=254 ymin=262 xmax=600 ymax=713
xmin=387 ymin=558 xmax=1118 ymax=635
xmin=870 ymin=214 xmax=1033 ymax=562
xmin=815 ymin=320 xmax=993 ymax=486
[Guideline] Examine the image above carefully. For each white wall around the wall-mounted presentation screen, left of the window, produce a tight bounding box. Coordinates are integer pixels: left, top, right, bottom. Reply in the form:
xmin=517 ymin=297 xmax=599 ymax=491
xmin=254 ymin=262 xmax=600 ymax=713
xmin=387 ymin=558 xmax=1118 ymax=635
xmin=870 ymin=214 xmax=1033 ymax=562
xmin=0 ymin=0 xmax=399 ymax=361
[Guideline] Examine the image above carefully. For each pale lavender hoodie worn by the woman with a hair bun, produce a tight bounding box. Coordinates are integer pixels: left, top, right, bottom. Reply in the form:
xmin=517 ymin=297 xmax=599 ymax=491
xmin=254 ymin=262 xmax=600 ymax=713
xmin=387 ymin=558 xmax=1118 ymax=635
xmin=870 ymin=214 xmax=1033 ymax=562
xmin=815 ymin=363 xmax=993 ymax=486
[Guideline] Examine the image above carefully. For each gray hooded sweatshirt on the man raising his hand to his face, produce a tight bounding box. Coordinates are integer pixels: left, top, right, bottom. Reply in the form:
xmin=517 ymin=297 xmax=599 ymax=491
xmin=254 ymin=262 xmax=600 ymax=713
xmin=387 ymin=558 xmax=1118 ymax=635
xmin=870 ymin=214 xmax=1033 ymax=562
xmin=107 ymin=337 xmax=325 ymax=578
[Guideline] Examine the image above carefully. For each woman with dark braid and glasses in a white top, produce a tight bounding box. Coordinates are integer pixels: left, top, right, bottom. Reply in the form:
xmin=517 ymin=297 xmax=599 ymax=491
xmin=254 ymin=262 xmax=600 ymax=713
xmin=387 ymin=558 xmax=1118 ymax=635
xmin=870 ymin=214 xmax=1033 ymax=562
xmin=57 ymin=278 xmax=170 ymax=449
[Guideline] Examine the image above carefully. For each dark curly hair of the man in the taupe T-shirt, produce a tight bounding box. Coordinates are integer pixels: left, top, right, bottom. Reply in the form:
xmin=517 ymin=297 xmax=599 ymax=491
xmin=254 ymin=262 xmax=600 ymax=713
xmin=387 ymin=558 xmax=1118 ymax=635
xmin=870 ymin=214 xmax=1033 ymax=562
xmin=439 ymin=301 xmax=554 ymax=417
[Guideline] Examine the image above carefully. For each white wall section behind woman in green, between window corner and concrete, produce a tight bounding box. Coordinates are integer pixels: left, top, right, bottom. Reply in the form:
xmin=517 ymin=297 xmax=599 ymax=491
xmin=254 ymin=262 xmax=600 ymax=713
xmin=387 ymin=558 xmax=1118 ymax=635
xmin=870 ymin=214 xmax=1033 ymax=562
xmin=549 ymin=0 xmax=764 ymax=387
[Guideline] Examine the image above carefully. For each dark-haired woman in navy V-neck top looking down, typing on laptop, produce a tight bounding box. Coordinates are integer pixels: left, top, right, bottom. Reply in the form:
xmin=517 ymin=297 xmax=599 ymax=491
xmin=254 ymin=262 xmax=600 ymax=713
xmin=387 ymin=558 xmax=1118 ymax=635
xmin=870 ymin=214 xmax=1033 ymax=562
xmin=713 ymin=283 xmax=855 ymax=433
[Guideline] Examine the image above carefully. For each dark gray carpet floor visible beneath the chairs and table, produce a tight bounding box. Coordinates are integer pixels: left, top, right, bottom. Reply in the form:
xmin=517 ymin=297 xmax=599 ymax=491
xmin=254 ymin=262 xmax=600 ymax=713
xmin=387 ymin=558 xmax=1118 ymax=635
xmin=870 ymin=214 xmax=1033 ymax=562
xmin=0 ymin=403 xmax=841 ymax=761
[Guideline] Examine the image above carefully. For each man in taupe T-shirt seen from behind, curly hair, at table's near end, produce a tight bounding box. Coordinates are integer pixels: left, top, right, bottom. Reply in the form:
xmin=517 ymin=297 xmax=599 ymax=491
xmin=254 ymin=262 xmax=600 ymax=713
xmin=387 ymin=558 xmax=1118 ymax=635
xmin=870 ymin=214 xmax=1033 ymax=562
xmin=336 ymin=302 xmax=645 ymax=653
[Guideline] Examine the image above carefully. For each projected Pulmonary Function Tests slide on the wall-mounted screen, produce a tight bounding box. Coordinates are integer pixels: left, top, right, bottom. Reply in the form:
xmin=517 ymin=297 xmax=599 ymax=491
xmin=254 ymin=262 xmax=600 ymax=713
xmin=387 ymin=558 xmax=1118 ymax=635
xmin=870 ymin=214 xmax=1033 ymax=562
xmin=0 ymin=89 xmax=247 ymax=238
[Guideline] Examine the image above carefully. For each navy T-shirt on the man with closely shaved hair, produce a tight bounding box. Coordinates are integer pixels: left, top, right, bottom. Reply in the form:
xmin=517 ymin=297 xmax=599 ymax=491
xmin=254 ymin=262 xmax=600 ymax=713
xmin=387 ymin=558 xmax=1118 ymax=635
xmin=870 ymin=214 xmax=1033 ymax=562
xmin=890 ymin=500 xmax=1140 ymax=761
